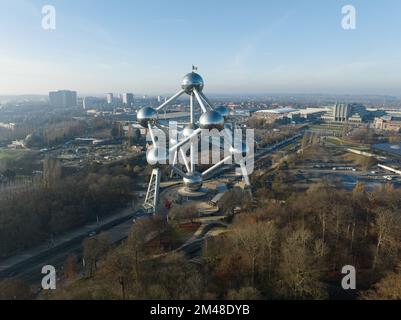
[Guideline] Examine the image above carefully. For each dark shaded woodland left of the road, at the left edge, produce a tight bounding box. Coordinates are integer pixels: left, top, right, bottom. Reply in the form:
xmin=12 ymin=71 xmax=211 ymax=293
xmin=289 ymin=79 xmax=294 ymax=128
xmin=0 ymin=173 xmax=134 ymax=257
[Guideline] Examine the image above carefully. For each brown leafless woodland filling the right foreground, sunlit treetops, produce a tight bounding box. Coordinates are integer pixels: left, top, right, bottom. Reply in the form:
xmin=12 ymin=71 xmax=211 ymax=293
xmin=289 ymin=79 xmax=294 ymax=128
xmin=14 ymin=183 xmax=401 ymax=299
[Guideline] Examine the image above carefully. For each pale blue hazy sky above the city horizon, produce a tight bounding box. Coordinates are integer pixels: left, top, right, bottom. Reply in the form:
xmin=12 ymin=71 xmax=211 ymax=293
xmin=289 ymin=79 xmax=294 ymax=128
xmin=0 ymin=0 xmax=401 ymax=96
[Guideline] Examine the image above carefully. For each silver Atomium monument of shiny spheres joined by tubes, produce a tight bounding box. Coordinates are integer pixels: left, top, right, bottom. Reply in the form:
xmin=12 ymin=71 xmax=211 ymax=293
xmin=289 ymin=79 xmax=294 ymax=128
xmin=137 ymin=70 xmax=250 ymax=214
